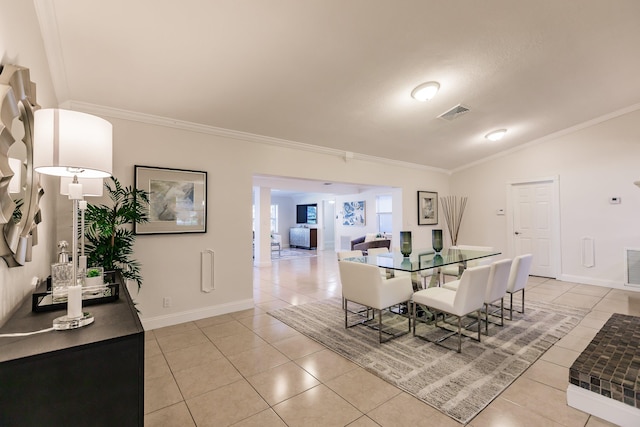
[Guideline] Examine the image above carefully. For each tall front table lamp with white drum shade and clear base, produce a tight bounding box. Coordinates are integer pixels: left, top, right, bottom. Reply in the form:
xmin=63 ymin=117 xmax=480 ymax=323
xmin=33 ymin=109 xmax=112 ymax=330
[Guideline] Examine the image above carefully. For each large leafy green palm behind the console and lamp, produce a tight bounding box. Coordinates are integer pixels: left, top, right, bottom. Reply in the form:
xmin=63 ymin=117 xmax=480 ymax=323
xmin=85 ymin=177 xmax=149 ymax=289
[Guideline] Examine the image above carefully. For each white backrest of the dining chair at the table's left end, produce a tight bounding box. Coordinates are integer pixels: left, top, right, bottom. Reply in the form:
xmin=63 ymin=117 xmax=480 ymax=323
xmin=338 ymin=261 xmax=382 ymax=307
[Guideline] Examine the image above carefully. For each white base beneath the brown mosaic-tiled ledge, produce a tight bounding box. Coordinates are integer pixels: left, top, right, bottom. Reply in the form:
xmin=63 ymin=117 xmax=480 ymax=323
xmin=567 ymin=384 xmax=640 ymax=427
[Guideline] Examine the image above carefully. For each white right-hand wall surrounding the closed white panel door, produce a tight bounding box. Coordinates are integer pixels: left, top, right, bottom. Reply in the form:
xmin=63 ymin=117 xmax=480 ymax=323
xmin=451 ymin=110 xmax=640 ymax=287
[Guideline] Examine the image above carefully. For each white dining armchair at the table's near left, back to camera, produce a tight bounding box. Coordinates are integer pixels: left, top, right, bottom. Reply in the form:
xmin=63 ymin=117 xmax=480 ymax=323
xmin=338 ymin=261 xmax=413 ymax=343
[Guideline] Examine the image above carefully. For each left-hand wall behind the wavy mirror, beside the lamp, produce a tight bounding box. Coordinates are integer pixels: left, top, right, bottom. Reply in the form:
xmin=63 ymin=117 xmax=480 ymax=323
xmin=0 ymin=0 xmax=57 ymax=325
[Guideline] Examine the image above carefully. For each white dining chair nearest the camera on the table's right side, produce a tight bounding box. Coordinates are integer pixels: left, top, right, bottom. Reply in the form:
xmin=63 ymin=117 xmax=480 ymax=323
xmin=411 ymin=265 xmax=490 ymax=353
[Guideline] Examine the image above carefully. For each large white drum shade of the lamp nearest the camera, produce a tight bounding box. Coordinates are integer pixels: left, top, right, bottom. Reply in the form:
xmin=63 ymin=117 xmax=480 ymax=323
xmin=33 ymin=108 xmax=113 ymax=178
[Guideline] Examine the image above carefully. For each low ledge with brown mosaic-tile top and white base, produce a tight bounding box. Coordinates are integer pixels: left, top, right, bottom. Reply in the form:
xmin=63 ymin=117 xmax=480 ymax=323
xmin=567 ymin=313 xmax=640 ymax=426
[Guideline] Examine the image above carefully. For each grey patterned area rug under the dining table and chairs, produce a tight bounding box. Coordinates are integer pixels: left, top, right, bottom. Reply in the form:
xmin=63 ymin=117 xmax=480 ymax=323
xmin=269 ymin=298 xmax=588 ymax=424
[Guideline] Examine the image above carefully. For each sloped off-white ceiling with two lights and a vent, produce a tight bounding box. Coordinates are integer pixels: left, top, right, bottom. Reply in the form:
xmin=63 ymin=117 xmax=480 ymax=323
xmin=36 ymin=0 xmax=640 ymax=174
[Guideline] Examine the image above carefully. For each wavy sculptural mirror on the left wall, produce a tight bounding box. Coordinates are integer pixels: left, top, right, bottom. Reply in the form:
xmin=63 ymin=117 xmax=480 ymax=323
xmin=0 ymin=65 xmax=44 ymax=267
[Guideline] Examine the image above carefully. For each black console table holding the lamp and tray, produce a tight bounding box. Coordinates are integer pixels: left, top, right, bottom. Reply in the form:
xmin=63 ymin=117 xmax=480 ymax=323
xmin=0 ymin=278 xmax=144 ymax=427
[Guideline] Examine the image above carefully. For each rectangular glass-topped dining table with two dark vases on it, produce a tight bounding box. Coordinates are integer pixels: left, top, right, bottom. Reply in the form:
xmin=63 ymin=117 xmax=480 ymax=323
xmin=345 ymin=248 xmax=500 ymax=289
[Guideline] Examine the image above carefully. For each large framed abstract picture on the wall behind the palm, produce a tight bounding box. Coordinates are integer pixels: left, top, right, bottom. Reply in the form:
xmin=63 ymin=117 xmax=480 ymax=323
xmin=134 ymin=165 xmax=207 ymax=234
